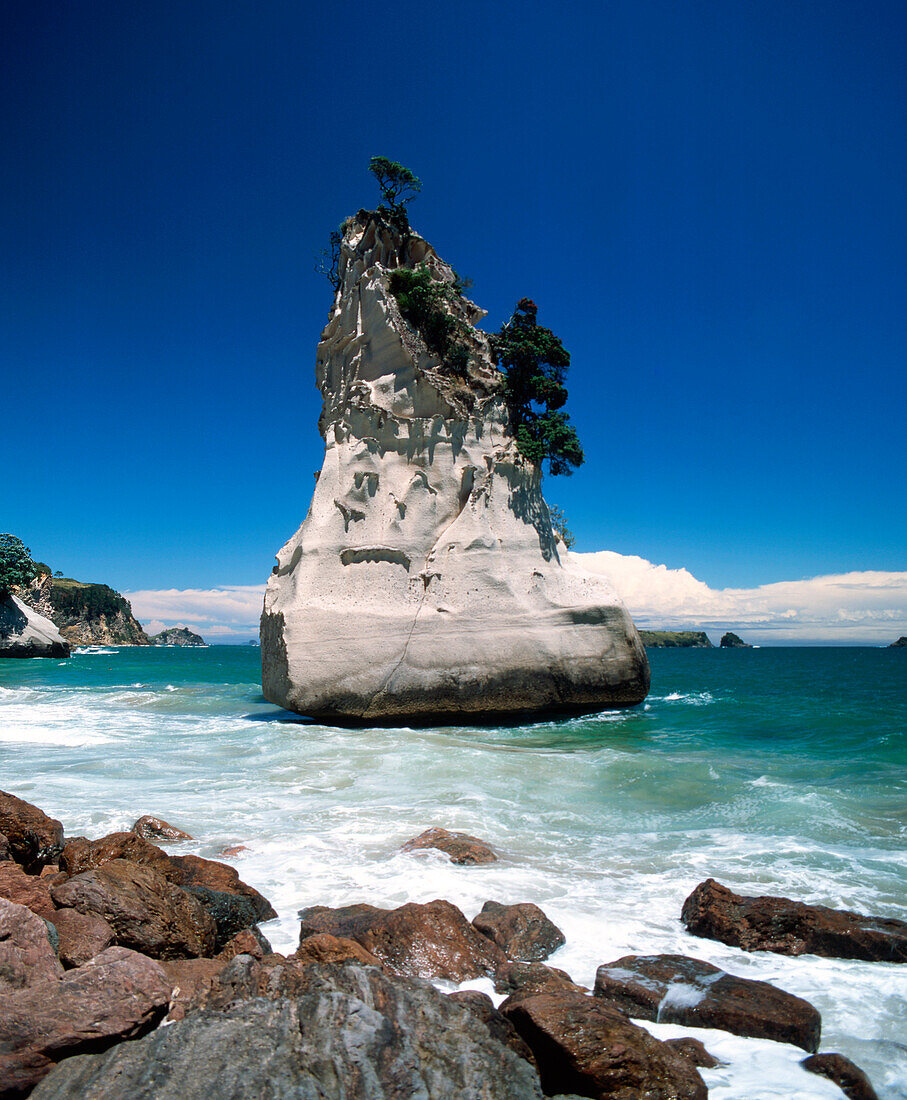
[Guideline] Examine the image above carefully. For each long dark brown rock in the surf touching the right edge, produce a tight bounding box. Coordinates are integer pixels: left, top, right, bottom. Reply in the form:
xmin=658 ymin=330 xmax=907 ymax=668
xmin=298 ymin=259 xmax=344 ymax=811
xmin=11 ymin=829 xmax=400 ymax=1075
xmin=681 ymin=879 xmax=907 ymax=963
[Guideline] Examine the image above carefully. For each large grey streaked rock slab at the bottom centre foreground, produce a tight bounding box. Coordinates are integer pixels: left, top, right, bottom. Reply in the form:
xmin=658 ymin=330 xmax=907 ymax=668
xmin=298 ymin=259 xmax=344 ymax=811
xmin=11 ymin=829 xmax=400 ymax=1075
xmin=34 ymin=967 xmax=542 ymax=1100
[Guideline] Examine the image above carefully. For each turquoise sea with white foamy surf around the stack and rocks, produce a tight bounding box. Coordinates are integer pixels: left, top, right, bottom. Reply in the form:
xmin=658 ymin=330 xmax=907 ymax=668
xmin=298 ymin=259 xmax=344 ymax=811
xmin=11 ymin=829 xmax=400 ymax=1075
xmin=0 ymin=646 xmax=907 ymax=1100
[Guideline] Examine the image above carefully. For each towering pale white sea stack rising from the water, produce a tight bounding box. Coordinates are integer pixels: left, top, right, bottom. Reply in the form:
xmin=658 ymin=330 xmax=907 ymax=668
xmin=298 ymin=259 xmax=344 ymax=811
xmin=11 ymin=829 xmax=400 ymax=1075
xmin=262 ymin=211 xmax=649 ymax=724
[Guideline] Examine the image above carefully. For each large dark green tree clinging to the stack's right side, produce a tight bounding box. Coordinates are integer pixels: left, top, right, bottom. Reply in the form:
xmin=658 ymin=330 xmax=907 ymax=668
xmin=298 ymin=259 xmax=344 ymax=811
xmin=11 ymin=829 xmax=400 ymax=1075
xmin=490 ymin=298 xmax=584 ymax=474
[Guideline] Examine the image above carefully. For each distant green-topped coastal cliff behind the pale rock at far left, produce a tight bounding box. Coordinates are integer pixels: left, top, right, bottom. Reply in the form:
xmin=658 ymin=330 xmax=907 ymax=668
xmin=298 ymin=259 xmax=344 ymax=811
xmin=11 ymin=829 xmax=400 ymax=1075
xmin=16 ymin=573 xmax=151 ymax=646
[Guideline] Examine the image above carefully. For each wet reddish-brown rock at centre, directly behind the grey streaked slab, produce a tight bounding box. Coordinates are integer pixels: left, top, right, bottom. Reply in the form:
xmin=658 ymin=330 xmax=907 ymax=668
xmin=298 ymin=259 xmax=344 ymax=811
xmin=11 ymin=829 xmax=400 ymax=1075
xmin=299 ymin=901 xmax=506 ymax=981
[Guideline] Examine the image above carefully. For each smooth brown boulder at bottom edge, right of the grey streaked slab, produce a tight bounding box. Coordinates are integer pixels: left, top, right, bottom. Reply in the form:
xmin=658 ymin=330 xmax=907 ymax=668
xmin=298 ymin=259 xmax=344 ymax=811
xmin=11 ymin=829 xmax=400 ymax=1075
xmin=501 ymin=992 xmax=708 ymax=1100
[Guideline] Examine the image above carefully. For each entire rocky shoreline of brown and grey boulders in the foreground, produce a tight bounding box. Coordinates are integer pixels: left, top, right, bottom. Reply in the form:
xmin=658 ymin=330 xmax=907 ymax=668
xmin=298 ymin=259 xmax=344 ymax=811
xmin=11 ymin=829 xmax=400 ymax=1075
xmin=0 ymin=792 xmax=907 ymax=1100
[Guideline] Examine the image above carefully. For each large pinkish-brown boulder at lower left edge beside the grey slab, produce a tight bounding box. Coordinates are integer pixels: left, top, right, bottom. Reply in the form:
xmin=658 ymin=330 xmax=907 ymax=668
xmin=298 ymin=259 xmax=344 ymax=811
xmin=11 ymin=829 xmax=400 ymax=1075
xmin=0 ymin=947 xmax=170 ymax=1098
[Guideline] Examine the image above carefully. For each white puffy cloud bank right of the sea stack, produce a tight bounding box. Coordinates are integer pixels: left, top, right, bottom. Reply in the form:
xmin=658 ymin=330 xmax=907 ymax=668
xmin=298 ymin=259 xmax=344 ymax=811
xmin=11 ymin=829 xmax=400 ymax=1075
xmin=572 ymin=550 xmax=907 ymax=645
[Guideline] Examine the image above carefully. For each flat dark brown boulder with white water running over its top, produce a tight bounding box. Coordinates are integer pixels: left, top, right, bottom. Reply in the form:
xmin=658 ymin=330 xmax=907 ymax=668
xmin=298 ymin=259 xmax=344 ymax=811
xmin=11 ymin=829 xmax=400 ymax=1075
xmin=595 ymin=955 xmax=822 ymax=1052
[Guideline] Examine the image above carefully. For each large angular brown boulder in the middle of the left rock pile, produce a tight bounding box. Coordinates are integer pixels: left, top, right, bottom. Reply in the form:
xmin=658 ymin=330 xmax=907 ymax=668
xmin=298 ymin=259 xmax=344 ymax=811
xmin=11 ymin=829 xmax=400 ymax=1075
xmin=53 ymin=859 xmax=217 ymax=959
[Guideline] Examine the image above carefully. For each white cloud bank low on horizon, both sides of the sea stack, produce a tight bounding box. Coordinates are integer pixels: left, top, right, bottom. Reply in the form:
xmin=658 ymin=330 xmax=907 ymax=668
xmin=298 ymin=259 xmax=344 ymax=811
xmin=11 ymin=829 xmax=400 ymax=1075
xmin=124 ymin=550 xmax=907 ymax=646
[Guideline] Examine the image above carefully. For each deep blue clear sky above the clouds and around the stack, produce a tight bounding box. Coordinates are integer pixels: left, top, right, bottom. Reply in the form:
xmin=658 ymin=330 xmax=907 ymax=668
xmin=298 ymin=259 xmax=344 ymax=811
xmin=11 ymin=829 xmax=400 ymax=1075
xmin=0 ymin=0 xmax=907 ymax=590
